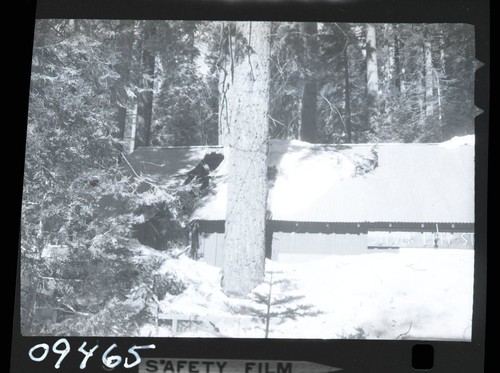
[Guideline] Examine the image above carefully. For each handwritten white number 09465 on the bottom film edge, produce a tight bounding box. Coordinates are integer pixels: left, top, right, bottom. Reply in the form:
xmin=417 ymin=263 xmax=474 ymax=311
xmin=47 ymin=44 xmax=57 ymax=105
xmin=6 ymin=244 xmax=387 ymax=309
xmin=28 ymin=338 xmax=156 ymax=369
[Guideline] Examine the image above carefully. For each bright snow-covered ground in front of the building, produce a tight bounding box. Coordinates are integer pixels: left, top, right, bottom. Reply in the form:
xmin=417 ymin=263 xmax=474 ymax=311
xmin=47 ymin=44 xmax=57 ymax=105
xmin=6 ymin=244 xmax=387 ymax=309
xmin=141 ymin=248 xmax=474 ymax=340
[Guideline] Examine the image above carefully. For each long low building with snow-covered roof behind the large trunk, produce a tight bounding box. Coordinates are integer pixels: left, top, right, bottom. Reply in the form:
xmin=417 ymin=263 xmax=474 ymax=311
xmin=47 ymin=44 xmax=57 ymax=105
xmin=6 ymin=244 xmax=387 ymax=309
xmin=130 ymin=138 xmax=474 ymax=266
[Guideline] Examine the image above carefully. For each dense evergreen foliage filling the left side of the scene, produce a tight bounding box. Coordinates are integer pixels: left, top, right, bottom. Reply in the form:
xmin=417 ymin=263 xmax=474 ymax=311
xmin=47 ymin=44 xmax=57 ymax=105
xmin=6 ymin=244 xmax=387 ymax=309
xmin=21 ymin=20 xmax=190 ymax=335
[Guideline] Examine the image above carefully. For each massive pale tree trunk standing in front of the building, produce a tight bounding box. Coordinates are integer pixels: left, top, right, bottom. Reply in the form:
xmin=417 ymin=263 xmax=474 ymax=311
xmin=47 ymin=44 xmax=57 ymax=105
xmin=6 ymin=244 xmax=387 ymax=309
xmin=222 ymin=22 xmax=271 ymax=295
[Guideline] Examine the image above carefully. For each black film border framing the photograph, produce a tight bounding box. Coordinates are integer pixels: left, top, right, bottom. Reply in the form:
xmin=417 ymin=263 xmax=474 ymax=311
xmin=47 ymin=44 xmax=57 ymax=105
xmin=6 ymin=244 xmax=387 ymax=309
xmin=10 ymin=0 xmax=491 ymax=373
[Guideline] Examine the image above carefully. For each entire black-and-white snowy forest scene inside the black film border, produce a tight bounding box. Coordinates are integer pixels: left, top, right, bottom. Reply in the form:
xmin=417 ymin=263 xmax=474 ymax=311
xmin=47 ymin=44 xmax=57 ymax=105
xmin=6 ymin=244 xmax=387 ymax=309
xmin=20 ymin=19 xmax=480 ymax=341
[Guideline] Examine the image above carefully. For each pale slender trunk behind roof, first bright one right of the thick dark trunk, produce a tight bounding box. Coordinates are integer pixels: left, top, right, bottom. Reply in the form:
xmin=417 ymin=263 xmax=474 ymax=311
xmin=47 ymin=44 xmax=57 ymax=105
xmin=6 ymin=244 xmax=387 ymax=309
xmin=366 ymin=24 xmax=378 ymax=131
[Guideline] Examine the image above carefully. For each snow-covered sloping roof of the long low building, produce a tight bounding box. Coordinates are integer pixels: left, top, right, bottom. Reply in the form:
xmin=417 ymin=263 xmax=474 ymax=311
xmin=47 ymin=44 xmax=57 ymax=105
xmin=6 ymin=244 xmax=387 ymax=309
xmin=127 ymin=136 xmax=474 ymax=223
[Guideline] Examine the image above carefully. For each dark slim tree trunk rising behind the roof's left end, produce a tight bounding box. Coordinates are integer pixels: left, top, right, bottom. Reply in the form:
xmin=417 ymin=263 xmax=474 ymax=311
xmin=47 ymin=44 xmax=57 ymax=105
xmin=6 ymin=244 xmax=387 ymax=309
xmin=134 ymin=21 xmax=156 ymax=148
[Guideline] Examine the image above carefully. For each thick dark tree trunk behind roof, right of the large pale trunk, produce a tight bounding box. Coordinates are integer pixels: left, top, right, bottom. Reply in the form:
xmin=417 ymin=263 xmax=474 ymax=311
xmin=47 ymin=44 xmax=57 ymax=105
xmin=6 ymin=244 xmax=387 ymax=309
xmin=300 ymin=22 xmax=318 ymax=143
